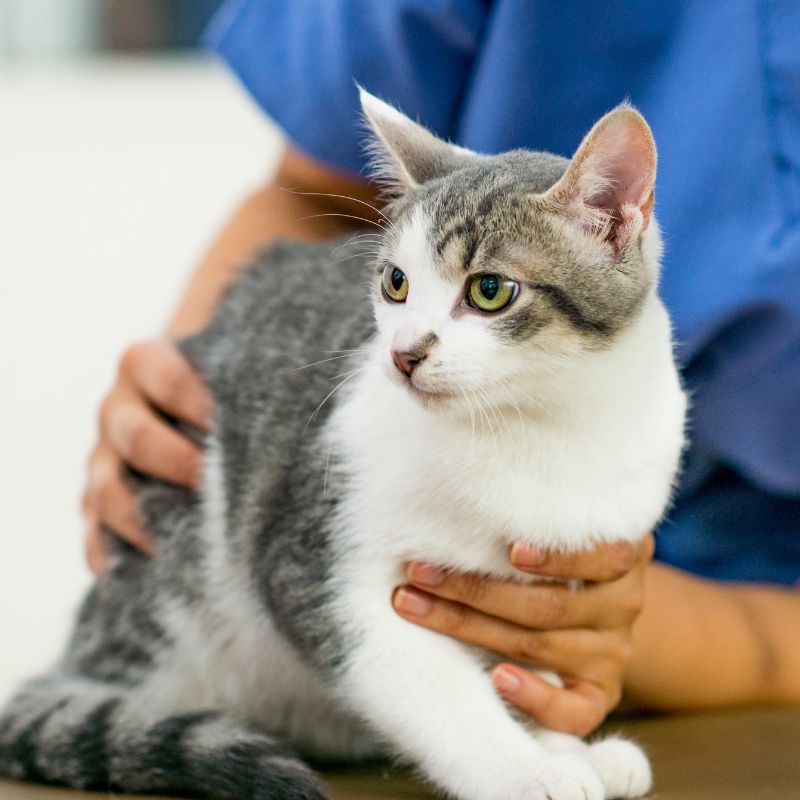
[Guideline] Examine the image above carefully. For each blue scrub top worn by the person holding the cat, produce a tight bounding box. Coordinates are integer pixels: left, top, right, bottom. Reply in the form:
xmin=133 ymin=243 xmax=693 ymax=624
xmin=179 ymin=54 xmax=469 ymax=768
xmin=209 ymin=0 xmax=800 ymax=584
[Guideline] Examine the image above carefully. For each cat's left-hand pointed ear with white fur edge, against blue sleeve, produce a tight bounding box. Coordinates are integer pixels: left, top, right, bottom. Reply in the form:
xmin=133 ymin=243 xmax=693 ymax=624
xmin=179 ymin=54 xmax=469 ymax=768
xmin=359 ymin=87 xmax=480 ymax=193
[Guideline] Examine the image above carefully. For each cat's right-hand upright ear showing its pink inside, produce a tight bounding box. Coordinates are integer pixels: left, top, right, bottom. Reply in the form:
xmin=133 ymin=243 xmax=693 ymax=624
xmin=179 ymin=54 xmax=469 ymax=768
xmin=541 ymin=103 xmax=656 ymax=256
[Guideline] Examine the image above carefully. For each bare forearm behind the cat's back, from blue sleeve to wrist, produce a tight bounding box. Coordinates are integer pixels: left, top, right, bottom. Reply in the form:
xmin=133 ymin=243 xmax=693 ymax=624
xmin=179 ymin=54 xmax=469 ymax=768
xmin=167 ymin=148 xmax=374 ymax=336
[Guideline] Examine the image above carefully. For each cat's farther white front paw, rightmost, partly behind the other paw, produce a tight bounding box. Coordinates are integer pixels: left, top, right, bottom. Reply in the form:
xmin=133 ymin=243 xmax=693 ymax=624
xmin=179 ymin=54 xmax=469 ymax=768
xmin=535 ymin=728 xmax=653 ymax=800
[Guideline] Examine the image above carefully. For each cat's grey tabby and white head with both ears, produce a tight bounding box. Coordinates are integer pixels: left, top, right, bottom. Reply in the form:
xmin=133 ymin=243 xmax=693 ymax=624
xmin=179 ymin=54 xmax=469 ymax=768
xmin=361 ymin=90 xmax=659 ymax=408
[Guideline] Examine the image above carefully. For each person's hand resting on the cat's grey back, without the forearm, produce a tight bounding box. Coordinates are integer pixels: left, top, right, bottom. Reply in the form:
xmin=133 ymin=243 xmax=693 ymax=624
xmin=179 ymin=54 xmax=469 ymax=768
xmin=83 ymin=340 xmax=211 ymax=574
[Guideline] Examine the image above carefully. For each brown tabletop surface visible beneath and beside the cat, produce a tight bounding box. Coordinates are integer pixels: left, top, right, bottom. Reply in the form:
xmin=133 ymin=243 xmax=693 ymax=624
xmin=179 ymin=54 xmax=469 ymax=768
xmin=0 ymin=708 xmax=800 ymax=800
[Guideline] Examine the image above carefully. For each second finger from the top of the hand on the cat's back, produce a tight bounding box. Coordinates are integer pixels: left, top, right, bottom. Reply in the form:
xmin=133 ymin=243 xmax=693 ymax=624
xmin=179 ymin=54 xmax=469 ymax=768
xmin=104 ymin=403 xmax=203 ymax=488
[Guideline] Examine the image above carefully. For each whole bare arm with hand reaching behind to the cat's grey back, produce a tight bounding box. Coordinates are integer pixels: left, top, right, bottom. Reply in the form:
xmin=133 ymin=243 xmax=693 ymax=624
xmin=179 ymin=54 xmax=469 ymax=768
xmin=83 ymin=147 xmax=377 ymax=573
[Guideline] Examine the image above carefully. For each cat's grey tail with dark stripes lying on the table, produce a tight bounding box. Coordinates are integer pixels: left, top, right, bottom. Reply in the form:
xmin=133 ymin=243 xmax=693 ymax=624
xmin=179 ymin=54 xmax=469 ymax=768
xmin=0 ymin=678 xmax=328 ymax=800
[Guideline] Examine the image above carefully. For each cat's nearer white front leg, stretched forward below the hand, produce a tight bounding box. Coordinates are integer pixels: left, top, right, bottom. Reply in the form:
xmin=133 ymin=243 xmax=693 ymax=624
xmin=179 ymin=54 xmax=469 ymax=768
xmin=340 ymin=604 xmax=605 ymax=800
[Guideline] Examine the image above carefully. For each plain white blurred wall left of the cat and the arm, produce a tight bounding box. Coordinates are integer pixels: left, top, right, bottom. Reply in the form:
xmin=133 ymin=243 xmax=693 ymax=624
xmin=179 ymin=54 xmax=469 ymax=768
xmin=0 ymin=60 xmax=280 ymax=702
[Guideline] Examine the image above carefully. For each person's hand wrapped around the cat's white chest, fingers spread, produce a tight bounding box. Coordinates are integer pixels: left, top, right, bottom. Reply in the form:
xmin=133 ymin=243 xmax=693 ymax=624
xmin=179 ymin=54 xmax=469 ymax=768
xmin=393 ymin=535 xmax=654 ymax=736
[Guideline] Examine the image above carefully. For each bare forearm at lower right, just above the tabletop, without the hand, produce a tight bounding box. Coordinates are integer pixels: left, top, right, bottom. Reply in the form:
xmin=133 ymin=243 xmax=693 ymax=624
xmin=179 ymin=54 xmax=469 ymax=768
xmin=625 ymin=564 xmax=800 ymax=710
